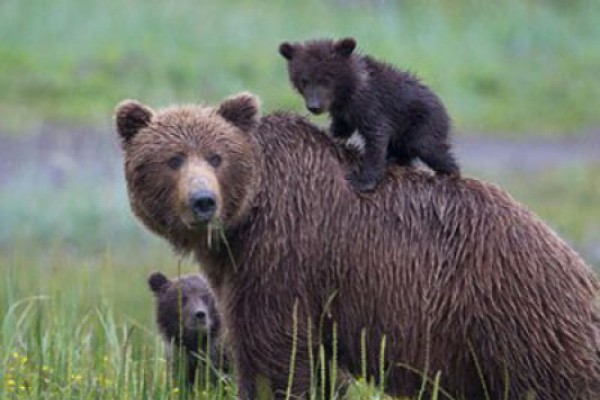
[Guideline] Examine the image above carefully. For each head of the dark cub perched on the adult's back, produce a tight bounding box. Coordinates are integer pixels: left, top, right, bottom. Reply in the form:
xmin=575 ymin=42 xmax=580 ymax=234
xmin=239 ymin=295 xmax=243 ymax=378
xmin=279 ymin=38 xmax=356 ymax=114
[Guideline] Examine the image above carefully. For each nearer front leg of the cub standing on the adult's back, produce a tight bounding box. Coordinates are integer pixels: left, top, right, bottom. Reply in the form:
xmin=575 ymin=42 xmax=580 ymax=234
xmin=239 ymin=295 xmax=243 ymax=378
xmin=348 ymin=123 xmax=391 ymax=192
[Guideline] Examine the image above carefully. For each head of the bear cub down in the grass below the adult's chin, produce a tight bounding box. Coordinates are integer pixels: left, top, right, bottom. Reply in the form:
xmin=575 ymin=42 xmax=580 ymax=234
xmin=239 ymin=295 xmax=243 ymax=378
xmin=148 ymin=272 xmax=220 ymax=343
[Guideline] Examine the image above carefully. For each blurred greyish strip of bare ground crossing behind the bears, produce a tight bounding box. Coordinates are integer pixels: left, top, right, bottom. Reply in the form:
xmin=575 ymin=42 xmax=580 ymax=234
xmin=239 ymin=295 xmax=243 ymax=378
xmin=0 ymin=125 xmax=600 ymax=182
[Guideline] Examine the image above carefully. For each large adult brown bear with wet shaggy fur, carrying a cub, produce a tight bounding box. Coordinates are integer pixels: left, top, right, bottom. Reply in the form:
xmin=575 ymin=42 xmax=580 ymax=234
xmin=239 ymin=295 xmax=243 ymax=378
xmin=116 ymin=94 xmax=600 ymax=400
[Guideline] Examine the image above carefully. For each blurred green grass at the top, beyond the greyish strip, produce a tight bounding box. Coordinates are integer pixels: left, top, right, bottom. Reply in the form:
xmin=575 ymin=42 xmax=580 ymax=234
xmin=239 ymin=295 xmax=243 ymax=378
xmin=0 ymin=0 xmax=600 ymax=134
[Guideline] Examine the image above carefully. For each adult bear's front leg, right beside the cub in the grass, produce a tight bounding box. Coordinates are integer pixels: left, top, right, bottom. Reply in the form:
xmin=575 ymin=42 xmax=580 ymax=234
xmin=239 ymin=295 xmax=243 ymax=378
xmin=226 ymin=298 xmax=318 ymax=400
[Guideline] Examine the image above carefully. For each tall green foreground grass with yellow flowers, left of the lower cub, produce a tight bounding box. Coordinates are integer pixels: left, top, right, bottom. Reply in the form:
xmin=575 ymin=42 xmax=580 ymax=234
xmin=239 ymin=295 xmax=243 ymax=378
xmin=0 ymin=247 xmax=404 ymax=399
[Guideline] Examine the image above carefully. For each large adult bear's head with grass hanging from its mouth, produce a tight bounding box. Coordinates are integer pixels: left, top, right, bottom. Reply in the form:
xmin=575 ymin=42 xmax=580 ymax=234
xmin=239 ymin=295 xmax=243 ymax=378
xmin=115 ymin=93 xmax=260 ymax=252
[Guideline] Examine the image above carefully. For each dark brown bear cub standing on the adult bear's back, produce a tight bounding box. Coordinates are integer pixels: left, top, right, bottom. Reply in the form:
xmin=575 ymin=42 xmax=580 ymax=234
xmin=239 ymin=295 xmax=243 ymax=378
xmin=279 ymin=38 xmax=460 ymax=191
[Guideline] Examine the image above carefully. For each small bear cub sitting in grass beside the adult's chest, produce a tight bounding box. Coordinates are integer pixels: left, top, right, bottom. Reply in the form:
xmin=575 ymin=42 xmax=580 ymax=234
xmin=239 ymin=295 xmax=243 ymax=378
xmin=148 ymin=272 xmax=229 ymax=387
